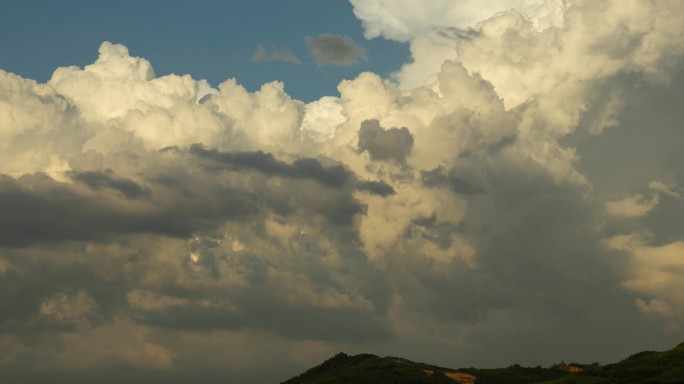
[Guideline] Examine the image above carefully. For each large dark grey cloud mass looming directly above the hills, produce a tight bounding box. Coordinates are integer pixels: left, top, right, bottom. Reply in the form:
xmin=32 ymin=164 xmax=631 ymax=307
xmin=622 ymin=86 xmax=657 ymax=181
xmin=380 ymin=151 xmax=672 ymax=365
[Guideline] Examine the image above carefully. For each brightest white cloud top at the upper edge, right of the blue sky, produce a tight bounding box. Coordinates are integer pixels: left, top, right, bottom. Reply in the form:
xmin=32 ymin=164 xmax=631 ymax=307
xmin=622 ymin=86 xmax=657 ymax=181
xmin=351 ymin=0 xmax=573 ymax=88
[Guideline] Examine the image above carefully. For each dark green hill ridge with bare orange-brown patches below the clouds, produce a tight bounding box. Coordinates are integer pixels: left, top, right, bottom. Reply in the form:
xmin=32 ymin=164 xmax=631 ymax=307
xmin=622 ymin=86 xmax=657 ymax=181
xmin=282 ymin=343 xmax=684 ymax=384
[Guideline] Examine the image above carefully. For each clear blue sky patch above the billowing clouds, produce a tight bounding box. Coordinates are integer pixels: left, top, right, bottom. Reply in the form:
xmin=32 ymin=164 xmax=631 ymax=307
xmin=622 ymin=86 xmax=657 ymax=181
xmin=0 ymin=0 xmax=409 ymax=101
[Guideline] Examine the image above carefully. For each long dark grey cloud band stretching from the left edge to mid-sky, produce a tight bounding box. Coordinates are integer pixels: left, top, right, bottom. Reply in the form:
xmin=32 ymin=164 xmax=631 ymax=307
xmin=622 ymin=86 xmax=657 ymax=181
xmin=0 ymin=145 xmax=400 ymax=246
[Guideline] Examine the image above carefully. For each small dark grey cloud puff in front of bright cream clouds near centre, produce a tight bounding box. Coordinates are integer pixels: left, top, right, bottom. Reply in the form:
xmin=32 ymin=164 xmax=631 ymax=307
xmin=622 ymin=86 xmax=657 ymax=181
xmin=358 ymin=120 xmax=413 ymax=163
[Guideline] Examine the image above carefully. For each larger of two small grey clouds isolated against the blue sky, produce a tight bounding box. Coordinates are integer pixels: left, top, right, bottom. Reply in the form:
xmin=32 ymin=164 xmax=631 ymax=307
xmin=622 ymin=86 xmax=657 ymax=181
xmin=306 ymin=33 xmax=367 ymax=67
